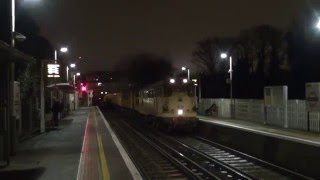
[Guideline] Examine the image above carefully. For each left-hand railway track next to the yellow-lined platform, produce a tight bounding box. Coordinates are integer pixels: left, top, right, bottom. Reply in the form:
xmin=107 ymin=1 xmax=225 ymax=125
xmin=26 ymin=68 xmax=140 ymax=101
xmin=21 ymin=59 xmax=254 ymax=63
xmin=104 ymin=112 xmax=251 ymax=179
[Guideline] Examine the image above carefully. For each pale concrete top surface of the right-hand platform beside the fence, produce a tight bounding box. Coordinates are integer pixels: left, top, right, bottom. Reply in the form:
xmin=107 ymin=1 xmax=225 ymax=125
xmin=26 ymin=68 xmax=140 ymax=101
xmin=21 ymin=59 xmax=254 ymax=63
xmin=198 ymin=116 xmax=320 ymax=147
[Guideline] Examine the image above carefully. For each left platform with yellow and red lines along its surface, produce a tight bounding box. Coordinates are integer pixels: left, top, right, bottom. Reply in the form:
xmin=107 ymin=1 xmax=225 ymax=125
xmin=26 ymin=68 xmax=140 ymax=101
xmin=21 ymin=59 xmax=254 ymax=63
xmin=0 ymin=107 xmax=141 ymax=180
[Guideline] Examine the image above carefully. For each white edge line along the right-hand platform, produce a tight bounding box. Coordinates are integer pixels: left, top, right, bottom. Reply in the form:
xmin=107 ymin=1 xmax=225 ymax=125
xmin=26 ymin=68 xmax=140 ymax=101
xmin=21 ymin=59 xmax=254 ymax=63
xmin=199 ymin=118 xmax=320 ymax=146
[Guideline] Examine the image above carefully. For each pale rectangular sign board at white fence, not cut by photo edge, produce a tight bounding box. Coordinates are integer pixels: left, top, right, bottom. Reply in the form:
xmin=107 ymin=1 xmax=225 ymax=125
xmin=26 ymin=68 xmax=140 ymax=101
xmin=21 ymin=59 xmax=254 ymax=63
xmin=264 ymin=86 xmax=288 ymax=106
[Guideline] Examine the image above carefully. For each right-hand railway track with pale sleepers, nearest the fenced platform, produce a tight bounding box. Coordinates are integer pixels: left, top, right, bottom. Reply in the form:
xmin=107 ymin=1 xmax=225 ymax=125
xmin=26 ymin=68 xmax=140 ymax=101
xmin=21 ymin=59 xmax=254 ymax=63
xmin=169 ymin=137 xmax=311 ymax=180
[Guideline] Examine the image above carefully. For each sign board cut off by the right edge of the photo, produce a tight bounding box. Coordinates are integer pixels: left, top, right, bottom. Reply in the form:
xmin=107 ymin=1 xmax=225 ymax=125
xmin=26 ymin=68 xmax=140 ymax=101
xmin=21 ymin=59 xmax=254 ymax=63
xmin=306 ymin=82 xmax=320 ymax=112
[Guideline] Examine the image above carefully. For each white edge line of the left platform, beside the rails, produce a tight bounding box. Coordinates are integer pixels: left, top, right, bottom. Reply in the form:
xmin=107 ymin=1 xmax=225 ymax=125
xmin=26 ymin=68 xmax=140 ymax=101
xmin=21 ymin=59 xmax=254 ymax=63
xmin=97 ymin=107 xmax=142 ymax=180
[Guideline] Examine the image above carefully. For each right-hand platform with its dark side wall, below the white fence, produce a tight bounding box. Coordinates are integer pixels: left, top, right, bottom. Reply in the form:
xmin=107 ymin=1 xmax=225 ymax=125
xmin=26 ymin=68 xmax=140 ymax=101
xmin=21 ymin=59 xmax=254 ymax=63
xmin=196 ymin=116 xmax=320 ymax=179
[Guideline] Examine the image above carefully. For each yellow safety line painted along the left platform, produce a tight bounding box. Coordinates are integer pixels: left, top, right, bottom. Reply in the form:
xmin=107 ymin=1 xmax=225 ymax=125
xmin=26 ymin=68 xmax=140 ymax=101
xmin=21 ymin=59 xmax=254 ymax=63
xmin=94 ymin=110 xmax=110 ymax=180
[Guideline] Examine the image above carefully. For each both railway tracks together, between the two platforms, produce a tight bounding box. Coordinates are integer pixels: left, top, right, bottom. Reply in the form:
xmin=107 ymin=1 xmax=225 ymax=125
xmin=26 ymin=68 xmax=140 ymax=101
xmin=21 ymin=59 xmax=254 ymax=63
xmin=104 ymin=112 xmax=308 ymax=180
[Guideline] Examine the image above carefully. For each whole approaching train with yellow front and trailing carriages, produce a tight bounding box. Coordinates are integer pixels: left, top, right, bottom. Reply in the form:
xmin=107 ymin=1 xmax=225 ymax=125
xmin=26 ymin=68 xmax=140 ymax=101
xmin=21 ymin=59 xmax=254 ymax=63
xmin=104 ymin=79 xmax=198 ymax=129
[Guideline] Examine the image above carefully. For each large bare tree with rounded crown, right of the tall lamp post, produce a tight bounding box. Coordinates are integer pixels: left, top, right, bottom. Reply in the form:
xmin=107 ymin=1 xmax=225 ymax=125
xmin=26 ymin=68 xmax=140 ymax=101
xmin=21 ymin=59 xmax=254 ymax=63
xmin=236 ymin=25 xmax=288 ymax=78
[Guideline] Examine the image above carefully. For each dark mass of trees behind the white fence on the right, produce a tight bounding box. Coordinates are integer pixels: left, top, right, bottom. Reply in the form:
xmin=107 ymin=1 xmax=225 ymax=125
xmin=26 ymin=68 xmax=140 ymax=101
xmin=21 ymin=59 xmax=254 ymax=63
xmin=193 ymin=16 xmax=320 ymax=99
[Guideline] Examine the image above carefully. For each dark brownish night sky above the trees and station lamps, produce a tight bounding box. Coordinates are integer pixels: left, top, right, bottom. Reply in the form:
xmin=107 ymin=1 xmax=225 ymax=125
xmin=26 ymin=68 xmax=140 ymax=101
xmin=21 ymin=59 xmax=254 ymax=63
xmin=24 ymin=0 xmax=305 ymax=71
